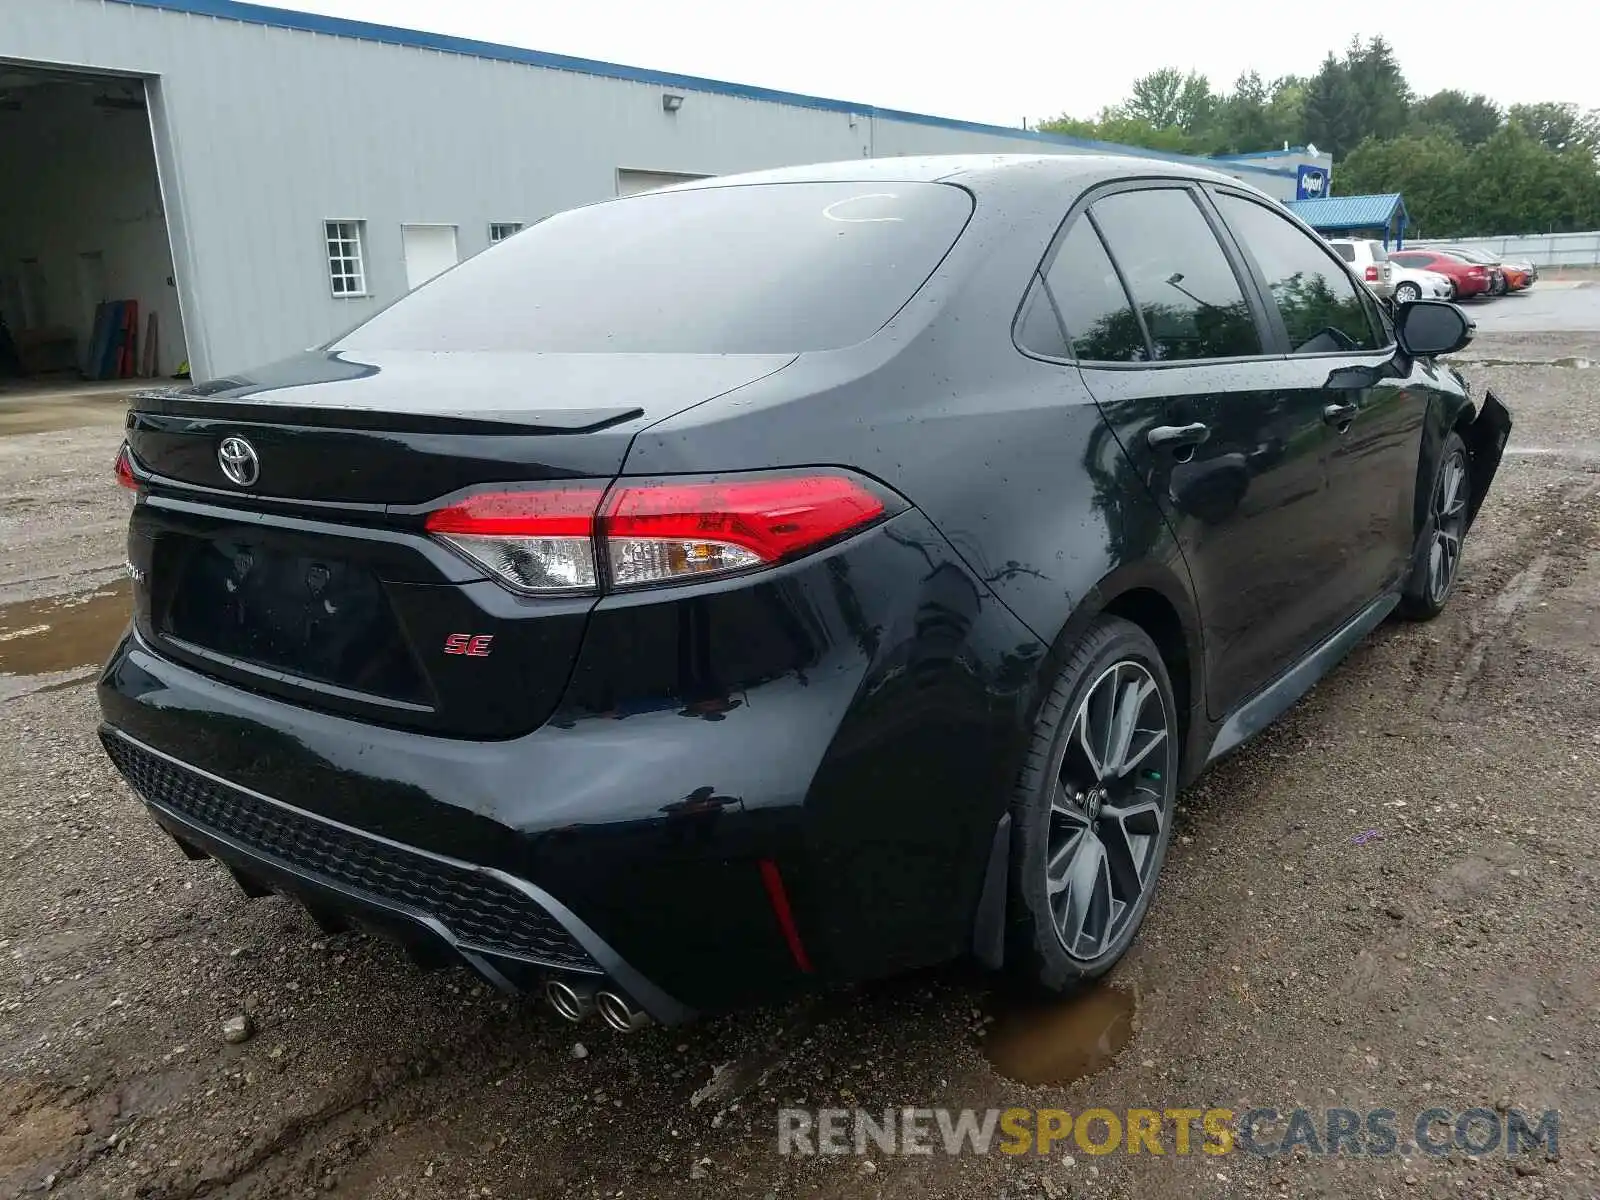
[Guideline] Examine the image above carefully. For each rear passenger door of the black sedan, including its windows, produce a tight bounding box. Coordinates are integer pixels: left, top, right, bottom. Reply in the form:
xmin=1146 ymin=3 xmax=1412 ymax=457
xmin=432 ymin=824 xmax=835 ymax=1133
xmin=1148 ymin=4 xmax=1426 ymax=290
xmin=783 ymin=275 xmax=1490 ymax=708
xmin=1046 ymin=184 xmax=1350 ymax=715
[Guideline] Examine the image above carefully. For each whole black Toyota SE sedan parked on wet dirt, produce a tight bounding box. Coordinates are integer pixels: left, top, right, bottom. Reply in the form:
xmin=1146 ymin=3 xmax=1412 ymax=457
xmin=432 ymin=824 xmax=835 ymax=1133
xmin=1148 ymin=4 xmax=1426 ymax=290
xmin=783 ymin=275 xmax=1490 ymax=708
xmin=99 ymin=157 xmax=1510 ymax=1029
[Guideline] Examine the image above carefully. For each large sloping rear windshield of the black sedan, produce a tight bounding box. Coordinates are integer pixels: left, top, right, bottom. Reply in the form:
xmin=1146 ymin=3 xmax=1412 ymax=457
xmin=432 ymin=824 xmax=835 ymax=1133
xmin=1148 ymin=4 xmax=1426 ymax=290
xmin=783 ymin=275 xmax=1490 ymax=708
xmin=336 ymin=182 xmax=973 ymax=354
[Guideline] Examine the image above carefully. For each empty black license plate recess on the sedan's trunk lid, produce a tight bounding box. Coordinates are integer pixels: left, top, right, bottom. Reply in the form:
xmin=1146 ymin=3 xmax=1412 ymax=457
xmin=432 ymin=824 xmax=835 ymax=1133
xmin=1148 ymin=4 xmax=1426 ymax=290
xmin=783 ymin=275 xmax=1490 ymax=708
xmin=155 ymin=534 xmax=432 ymax=706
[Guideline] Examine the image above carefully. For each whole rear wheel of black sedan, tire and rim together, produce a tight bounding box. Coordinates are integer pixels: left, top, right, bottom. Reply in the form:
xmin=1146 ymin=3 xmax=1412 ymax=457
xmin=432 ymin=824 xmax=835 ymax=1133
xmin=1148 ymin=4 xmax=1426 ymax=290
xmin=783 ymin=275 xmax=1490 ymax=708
xmin=1006 ymin=616 xmax=1181 ymax=995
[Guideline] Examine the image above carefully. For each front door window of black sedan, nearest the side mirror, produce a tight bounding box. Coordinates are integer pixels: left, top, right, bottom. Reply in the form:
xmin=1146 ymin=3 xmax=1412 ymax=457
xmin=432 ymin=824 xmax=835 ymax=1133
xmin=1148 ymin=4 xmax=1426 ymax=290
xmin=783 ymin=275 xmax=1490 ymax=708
xmin=1216 ymin=192 xmax=1379 ymax=354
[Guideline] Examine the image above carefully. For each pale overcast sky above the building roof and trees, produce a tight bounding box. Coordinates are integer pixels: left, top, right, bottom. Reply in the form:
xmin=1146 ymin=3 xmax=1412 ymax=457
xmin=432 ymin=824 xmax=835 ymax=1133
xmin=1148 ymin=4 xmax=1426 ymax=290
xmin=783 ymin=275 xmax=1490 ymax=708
xmin=294 ymin=0 xmax=1600 ymax=125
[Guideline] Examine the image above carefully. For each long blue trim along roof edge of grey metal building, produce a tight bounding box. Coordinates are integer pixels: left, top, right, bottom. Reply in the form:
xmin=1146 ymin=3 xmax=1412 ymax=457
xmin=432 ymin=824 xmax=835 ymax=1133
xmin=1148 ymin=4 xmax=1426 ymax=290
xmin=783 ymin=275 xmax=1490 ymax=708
xmin=112 ymin=0 xmax=1294 ymax=178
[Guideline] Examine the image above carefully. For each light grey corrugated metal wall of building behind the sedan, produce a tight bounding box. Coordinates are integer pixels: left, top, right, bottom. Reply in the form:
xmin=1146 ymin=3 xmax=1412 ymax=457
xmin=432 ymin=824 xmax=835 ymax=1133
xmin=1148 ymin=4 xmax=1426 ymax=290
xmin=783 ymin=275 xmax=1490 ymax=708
xmin=0 ymin=0 xmax=1293 ymax=378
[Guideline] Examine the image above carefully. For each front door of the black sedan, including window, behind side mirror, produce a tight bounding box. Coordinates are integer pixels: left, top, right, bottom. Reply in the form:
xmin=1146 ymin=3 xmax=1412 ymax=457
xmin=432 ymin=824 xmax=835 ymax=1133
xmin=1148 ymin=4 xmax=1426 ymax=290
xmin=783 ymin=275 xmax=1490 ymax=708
xmin=1213 ymin=189 xmax=1427 ymax=634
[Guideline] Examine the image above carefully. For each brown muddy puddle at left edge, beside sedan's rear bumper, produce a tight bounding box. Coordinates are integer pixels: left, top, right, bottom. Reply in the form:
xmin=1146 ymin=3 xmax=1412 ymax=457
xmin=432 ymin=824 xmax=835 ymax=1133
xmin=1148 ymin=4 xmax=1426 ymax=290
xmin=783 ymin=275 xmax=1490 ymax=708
xmin=0 ymin=579 xmax=133 ymax=699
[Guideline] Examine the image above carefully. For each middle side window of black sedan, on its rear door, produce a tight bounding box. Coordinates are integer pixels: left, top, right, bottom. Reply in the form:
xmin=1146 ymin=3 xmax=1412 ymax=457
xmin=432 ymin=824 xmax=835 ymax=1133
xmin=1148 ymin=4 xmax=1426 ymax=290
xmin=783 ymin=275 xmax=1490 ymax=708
xmin=1090 ymin=187 xmax=1261 ymax=362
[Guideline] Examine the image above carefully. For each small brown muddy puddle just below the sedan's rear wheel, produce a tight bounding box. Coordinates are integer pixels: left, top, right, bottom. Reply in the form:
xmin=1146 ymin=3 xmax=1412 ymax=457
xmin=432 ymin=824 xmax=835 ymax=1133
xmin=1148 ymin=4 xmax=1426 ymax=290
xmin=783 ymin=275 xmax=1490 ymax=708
xmin=984 ymin=986 xmax=1138 ymax=1083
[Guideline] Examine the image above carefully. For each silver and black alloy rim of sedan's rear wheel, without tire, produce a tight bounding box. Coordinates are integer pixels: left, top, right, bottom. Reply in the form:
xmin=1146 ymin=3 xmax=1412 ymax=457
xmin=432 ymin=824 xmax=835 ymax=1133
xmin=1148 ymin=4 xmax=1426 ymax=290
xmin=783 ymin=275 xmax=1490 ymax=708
xmin=1045 ymin=659 xmax=1174 ymax=962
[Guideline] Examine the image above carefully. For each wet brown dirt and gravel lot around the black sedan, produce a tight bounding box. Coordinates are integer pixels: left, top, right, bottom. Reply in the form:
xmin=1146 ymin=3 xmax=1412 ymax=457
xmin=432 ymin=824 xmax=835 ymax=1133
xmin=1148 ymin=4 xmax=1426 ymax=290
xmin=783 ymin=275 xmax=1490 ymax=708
xmin=0 ymin=334 xmax=1600 ymax=1200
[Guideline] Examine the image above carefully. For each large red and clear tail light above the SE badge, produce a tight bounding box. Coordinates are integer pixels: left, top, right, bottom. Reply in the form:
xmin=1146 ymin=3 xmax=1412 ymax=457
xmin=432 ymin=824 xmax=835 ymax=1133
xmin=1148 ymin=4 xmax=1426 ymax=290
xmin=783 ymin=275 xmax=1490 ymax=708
xmin=427 ymin=472 xmax=886 ymax=594
